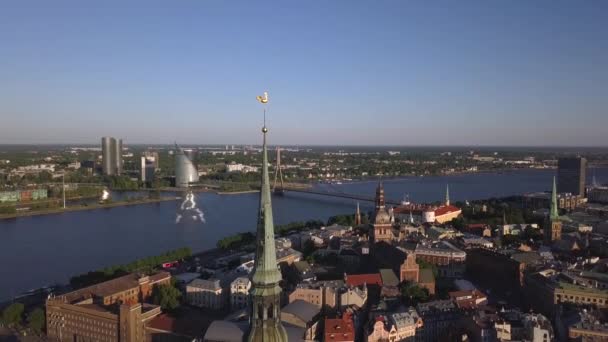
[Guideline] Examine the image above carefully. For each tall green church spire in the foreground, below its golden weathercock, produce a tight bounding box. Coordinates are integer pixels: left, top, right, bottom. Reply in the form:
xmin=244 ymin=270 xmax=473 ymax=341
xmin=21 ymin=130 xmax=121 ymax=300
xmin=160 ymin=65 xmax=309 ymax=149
xmin=247 ymin=125 xmax=287 ymax=342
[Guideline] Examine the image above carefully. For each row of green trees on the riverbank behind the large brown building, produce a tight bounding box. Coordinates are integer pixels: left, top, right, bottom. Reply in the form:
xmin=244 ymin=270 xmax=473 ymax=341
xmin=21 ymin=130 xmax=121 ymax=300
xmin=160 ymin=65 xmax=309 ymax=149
xmin=70 ymin=247 xmax=192 ymax=289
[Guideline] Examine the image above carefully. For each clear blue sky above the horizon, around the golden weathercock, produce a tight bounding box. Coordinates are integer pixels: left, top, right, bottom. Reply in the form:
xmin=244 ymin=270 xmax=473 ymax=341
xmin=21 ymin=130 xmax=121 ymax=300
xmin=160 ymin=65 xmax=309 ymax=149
xmin=0 ymin=0 xmax=608 ymax=146
